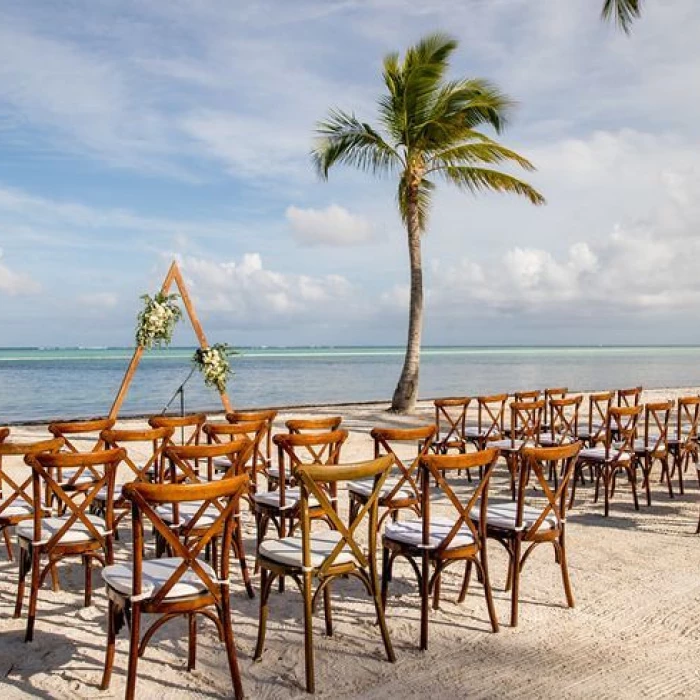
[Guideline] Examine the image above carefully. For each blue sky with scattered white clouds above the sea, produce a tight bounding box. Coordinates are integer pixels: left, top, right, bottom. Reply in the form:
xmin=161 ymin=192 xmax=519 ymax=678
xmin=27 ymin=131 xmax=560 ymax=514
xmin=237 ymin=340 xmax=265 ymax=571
xmin=0 ymin=0 xmax=700 ymax=346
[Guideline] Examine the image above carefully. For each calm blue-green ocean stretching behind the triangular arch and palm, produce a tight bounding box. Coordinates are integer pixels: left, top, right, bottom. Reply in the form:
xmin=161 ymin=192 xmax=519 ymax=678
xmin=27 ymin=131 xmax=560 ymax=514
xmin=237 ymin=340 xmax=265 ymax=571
xmin=0 ymin=346 xmax=700 ymax=425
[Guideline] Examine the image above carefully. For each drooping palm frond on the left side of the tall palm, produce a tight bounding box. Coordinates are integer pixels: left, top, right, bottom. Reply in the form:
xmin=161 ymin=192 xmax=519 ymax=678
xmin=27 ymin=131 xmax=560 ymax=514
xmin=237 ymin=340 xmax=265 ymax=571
xmin=311 ymin=110 xmax=401 ymax=179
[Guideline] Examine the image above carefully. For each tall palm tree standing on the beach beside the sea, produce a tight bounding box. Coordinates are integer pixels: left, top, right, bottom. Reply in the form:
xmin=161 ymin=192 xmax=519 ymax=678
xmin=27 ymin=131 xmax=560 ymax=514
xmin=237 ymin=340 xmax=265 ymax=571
xmin=312 ymin=34 xmax=544 ymax=413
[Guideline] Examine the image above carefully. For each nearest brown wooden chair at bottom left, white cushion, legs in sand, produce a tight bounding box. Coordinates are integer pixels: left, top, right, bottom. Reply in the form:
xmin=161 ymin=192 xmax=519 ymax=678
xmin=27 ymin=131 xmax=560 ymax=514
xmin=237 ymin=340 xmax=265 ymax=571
xmin=101 ymin=474 xmax=248 ymax=700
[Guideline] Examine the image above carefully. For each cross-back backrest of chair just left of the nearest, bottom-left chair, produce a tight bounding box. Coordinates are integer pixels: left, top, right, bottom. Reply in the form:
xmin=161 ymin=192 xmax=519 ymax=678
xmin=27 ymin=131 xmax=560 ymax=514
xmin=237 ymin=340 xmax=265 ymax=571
xmin=24 ymin=449 xmax=126 ymax=550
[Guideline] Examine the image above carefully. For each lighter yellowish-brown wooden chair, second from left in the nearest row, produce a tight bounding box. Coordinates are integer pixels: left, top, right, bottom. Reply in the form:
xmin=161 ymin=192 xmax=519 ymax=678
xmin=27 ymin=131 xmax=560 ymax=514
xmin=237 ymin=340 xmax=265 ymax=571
xmin=254 ymin=455 xmax=395 ymax=693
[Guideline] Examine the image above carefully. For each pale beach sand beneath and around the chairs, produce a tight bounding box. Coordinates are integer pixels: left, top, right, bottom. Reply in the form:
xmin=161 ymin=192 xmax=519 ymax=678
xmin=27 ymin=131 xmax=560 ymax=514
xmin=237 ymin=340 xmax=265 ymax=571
xmin=0 ymin=389 xmax=700 ymax=699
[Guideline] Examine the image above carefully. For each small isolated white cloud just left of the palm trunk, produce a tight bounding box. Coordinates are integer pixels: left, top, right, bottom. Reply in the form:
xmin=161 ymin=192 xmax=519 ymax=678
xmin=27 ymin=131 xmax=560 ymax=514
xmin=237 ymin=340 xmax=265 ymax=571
xmin=285 ymin=204 xmax=372 ymax=246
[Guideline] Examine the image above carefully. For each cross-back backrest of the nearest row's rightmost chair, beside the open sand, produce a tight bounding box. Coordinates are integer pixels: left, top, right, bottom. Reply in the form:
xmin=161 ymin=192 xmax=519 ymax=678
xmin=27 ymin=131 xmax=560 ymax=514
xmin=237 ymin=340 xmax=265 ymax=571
xmin=515 ymin=442 xmax=581 ymax=541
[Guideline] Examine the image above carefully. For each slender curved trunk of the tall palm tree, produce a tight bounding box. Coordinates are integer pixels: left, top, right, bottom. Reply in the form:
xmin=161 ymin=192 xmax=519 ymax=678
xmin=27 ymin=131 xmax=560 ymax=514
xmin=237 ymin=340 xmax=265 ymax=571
xmin=391 ymin=186 xmax=423 ymax=413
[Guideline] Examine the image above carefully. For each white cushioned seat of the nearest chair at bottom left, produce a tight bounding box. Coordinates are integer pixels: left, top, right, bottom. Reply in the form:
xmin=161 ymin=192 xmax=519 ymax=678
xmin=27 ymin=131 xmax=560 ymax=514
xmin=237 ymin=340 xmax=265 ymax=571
xmin=102 ymin=557 xmax=218 ymax=600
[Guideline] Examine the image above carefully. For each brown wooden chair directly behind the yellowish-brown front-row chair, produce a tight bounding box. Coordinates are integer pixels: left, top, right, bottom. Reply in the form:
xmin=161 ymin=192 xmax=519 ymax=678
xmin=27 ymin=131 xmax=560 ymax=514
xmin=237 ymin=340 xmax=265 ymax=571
xmin=253 ymin=430 xmax=348 ymax=556
